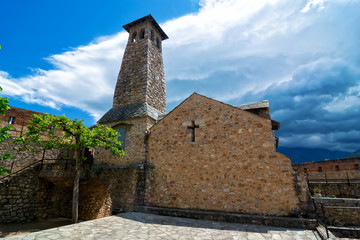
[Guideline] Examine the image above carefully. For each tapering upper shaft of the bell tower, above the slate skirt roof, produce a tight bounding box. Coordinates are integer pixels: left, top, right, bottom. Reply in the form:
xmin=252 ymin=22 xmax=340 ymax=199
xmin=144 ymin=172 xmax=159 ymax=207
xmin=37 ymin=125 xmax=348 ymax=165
xmin=113 ymin=15 xmax=168 ymax=114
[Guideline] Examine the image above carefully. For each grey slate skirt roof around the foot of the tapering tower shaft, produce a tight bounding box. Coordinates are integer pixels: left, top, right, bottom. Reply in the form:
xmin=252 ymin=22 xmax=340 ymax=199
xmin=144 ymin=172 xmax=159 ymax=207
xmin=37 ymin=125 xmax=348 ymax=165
xmin=98 ymin=102 xmax=162 ymax=123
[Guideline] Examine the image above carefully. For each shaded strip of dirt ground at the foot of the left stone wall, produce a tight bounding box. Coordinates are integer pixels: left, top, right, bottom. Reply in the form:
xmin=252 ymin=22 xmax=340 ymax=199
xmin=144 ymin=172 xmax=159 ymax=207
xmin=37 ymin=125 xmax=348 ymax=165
xmin=0 ymin=218 xmax=71 ymax=238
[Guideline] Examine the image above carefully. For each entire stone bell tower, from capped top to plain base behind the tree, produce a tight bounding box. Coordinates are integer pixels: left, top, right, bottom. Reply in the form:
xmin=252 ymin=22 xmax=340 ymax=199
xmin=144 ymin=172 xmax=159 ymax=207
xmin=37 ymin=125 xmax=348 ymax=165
xmin=98 ymin=15 xmax=168 ymax=167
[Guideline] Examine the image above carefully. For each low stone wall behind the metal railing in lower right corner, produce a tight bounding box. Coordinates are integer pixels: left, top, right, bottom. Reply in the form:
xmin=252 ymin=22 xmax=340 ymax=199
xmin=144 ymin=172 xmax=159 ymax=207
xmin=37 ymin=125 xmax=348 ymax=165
xmin=314 ymin=198 xmax=360 ymax=227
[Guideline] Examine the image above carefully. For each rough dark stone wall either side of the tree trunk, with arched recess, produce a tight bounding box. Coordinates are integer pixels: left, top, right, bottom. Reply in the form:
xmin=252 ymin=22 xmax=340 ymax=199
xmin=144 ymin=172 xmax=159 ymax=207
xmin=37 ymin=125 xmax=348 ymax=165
xmin=0 ymin=164 xmax=142 ymax=223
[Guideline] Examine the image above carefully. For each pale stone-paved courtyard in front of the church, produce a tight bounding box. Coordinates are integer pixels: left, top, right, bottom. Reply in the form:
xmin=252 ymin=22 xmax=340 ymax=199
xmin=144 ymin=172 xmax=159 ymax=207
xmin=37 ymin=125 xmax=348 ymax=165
xmin=4 ymin=212 xmax=320 ymax=240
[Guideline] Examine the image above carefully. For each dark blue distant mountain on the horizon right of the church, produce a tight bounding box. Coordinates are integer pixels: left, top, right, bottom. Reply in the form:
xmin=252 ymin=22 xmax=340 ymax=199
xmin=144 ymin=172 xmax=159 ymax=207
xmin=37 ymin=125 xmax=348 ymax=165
xmin=277 ymin=147 xmax=351 ymax=163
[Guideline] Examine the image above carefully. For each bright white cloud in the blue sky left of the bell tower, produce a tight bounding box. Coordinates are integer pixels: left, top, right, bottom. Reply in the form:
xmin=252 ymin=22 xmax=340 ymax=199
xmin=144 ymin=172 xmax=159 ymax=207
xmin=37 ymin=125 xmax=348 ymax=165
xmin=0 ymin=32 xmax=127 ymax=120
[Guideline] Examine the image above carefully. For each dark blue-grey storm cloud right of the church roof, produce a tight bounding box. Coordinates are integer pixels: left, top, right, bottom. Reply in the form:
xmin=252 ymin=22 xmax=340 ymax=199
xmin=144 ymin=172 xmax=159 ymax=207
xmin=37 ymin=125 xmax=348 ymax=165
xmin=250 ymin=59 xmax=360 ymax=151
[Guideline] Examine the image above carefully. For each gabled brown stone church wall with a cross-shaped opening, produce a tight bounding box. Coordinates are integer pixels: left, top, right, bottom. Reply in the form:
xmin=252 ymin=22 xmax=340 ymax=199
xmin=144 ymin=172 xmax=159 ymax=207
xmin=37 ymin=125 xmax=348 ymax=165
xmin=146 ymin=94 xmax=300 ymax=218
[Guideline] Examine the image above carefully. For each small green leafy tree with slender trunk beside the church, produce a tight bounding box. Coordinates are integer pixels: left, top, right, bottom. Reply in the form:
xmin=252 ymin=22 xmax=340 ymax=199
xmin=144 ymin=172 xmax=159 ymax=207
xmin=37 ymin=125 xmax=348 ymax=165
xmin=14 ymin=113 xmax=124 ymax=223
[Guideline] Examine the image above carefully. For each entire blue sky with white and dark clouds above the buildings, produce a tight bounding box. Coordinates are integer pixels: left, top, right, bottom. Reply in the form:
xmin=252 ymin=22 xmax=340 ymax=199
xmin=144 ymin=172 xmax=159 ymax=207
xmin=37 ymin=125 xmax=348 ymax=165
xmin=0 ymin=0 xmax=360 ymax=151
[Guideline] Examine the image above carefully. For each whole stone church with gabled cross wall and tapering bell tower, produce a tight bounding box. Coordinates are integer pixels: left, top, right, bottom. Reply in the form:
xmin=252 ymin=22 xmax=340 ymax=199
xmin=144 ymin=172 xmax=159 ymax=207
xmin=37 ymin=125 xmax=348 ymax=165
xmin=0 ymin=15 xmax=306 ymax=225
